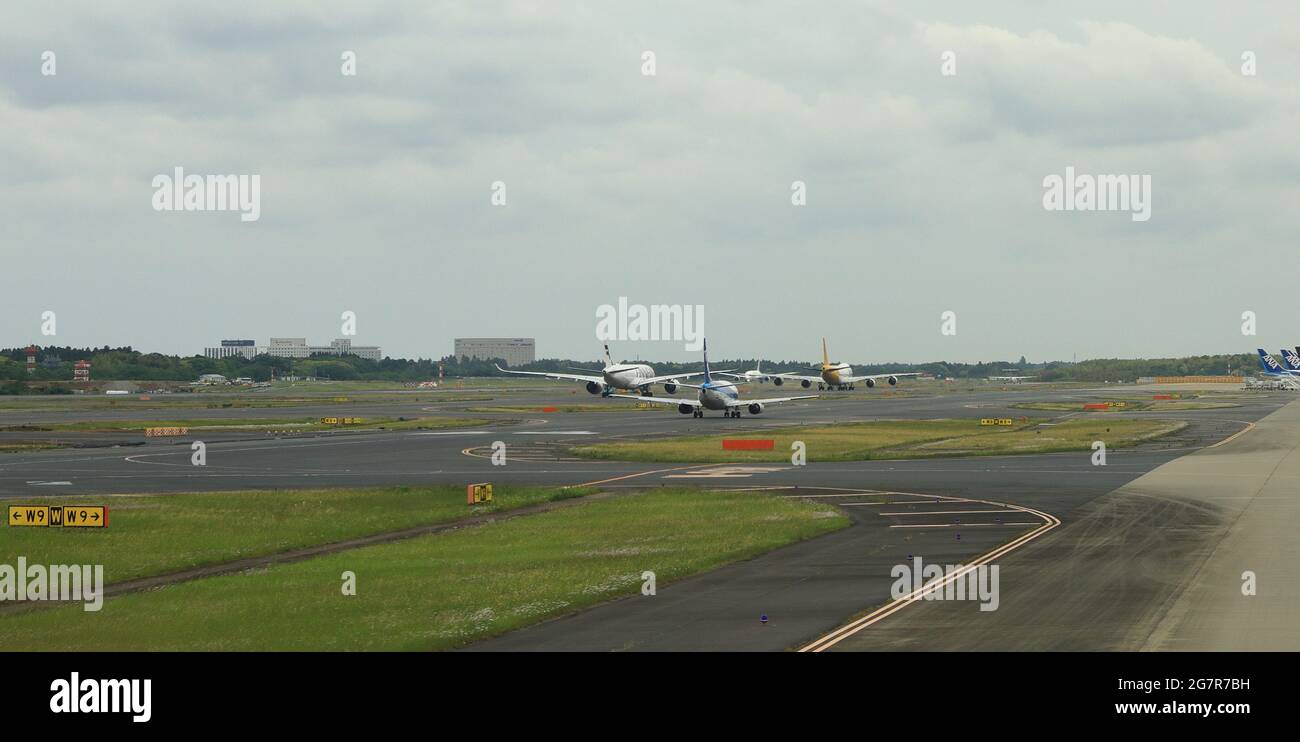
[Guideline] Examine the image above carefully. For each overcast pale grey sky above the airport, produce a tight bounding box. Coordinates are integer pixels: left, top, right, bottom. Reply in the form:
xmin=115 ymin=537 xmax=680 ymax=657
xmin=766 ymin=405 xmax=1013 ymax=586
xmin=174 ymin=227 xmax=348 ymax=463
xmin=0 ymin=1 xmax=1300 ymax=363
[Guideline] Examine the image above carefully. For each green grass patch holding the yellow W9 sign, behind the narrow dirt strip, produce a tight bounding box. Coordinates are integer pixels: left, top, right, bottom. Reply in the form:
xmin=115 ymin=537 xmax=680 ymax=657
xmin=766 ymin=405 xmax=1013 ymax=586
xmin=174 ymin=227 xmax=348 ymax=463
xmin=0 ymin=485 xmax=590 ymax=583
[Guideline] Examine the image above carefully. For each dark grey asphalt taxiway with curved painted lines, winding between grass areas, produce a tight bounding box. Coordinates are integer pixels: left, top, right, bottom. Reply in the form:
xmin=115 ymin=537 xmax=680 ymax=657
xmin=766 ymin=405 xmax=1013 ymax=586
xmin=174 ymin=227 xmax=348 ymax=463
xmin=0 ymin=387 xmax=1294 ymax=651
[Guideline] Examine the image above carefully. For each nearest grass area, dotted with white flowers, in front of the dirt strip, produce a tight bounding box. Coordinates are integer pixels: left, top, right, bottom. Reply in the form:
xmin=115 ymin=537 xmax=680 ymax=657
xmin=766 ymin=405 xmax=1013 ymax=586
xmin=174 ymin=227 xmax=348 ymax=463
xmin=0 ymin=490 xmax=848 ymax=651
